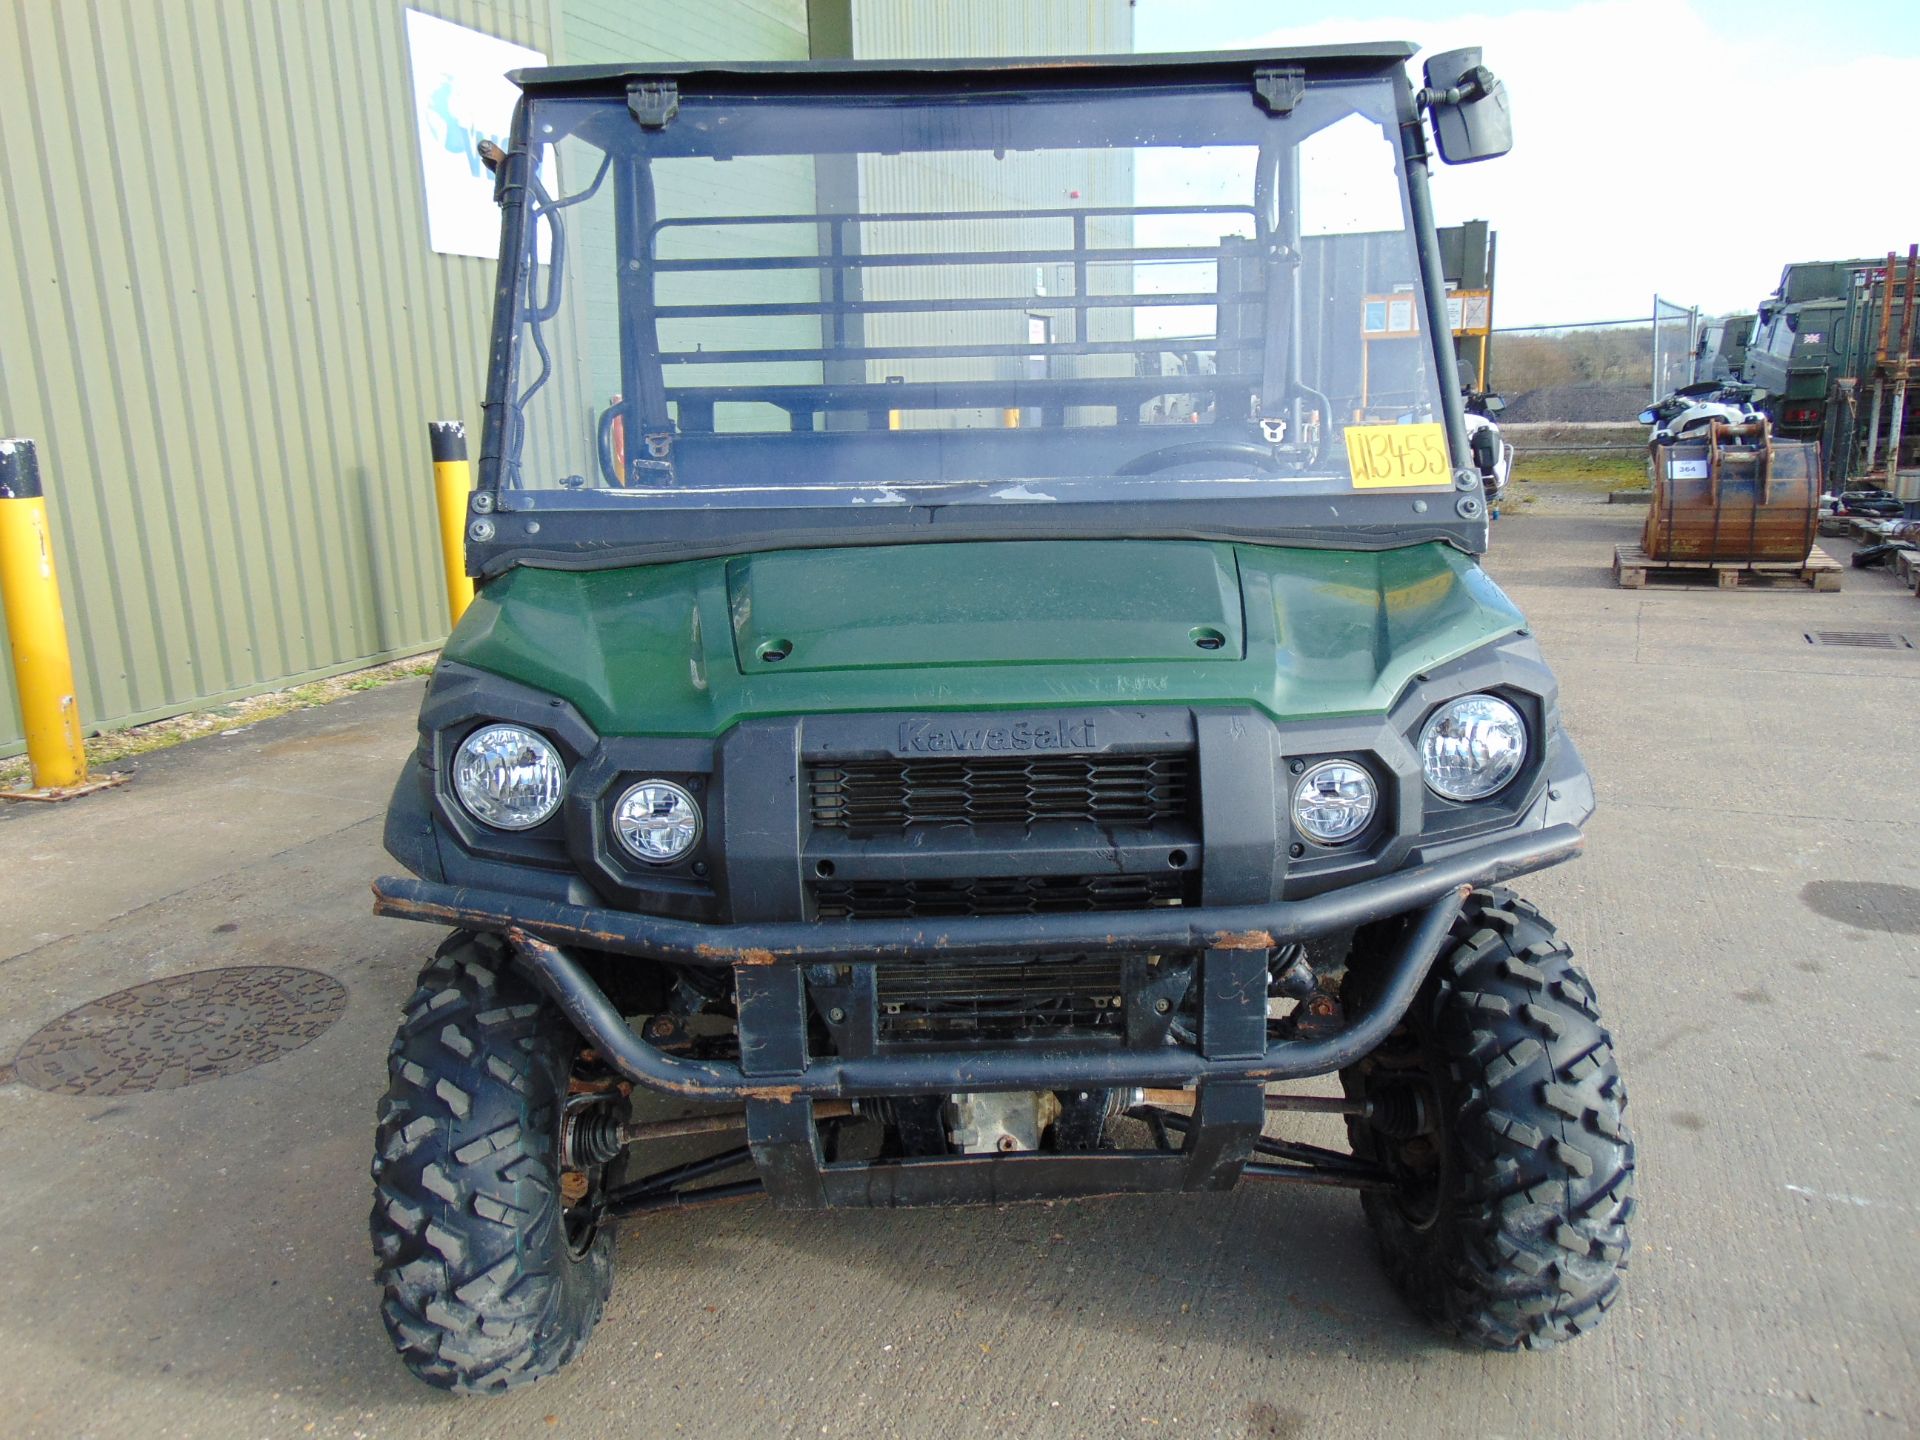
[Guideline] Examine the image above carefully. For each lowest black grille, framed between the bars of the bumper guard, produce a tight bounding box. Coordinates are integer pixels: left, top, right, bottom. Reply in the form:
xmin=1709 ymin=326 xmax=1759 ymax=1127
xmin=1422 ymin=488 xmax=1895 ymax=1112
xmin=874 ymin=956 xmax=1127 ymax=1041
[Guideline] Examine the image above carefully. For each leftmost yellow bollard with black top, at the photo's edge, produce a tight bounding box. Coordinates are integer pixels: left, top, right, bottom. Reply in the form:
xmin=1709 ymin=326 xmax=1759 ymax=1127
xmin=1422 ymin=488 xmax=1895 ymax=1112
xmin=0 ymin=440 xmax=125 ymax=801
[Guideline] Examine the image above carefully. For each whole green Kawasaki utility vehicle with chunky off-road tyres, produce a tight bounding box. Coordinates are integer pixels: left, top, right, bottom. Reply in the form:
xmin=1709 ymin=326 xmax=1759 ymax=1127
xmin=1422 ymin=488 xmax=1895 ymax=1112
xmin=372 ymin=44 xmax=1634 ymax=1390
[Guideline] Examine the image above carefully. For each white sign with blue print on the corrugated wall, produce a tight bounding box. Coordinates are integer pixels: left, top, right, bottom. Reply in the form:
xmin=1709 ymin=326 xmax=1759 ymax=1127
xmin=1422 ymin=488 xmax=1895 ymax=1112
xmin=407 ymin=10 xmax=547 ymax=259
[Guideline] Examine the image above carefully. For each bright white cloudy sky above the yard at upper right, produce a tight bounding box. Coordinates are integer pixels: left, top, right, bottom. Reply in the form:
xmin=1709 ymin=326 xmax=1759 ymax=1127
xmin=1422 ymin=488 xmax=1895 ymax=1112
xmin=1135 ymin=0 xmax=1920 ymax=324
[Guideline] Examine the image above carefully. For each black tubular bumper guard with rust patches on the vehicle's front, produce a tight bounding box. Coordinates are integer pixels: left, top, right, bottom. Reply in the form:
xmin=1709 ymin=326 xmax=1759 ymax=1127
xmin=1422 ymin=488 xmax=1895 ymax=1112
xmin=374 ymin=824 xmax=1584 ymax=1100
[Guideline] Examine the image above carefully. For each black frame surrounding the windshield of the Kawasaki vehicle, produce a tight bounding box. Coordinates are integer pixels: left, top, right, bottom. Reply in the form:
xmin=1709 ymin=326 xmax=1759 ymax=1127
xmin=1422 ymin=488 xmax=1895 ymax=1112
xmin=468 ymin=46 xmax=1486 ymax=574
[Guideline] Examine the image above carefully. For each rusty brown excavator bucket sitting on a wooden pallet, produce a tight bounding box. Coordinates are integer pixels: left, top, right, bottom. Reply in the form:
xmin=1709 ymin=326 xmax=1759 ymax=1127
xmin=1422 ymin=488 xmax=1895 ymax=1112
xmin=1640 ymin=417 xmax=1820 ymax=563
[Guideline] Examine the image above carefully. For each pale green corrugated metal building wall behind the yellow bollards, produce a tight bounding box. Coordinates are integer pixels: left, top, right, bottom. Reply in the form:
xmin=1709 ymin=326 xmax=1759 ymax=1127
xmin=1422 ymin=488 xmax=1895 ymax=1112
xmin=0 ymin=0 xmax=806 ymax=755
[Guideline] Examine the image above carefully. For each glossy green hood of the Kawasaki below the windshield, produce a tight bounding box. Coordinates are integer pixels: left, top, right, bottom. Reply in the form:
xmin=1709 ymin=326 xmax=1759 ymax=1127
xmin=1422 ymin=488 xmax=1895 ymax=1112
xmin=445 ymin=540 xmax=1524 ymax=735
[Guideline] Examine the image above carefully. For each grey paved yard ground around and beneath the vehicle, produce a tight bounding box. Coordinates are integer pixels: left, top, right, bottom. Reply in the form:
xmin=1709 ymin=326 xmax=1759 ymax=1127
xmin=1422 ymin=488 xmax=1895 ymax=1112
xmin=0 ymin=507 xmax=1920 ymax=1438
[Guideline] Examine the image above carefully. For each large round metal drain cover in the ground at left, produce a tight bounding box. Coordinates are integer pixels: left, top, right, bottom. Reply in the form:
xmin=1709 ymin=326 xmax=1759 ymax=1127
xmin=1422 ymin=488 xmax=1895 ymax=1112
xmin=13 ymin=966 xmax=348 ymax=1094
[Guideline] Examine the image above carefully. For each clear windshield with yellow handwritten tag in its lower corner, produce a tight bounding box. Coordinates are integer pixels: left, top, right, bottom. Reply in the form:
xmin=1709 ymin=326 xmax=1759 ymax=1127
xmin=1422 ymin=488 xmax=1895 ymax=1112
xmin=495 ymin=79 xmax=1452 ymax=509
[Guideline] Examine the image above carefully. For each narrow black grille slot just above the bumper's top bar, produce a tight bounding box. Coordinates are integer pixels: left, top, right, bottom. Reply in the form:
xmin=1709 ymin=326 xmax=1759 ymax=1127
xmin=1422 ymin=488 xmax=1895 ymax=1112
xmin=812 ymin=872 xmax=1200 ymax=920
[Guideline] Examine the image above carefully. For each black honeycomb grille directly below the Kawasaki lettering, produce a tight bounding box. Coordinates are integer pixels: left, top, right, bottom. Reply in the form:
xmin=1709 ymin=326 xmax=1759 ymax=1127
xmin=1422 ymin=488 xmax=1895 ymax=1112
xmin=810 ymin=753 xmax=1194 ymax=835
